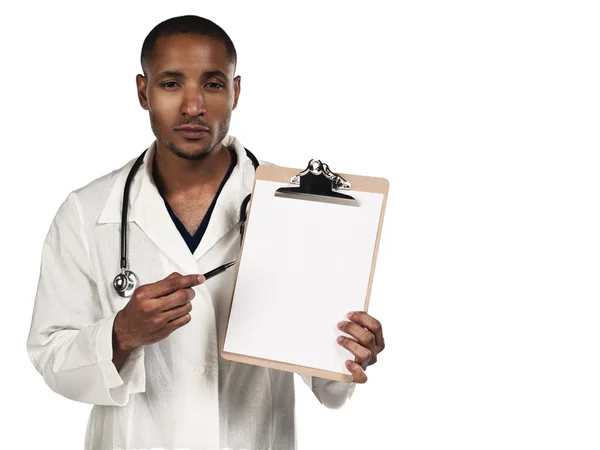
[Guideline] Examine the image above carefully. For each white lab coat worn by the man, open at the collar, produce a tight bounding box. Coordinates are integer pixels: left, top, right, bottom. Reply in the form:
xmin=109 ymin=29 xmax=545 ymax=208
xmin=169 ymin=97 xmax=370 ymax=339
xmin=27 ymin=136 xmax=355 ymax=450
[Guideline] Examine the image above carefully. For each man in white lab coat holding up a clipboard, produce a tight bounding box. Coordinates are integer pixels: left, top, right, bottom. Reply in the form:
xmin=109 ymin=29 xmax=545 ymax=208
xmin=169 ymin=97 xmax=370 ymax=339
xmin=27 ymin=16 xmax=384 ymax=450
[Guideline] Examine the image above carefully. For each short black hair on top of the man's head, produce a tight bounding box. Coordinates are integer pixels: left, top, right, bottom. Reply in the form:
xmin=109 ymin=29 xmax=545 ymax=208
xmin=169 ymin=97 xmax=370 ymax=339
xmin=140 ymin=15 xmax=237 ymax=75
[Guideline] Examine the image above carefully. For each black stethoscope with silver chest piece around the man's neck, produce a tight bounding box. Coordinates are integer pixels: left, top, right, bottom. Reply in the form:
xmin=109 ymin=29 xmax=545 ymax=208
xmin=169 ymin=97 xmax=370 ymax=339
xmin=113 ymin=148 xmax=259 ymax=298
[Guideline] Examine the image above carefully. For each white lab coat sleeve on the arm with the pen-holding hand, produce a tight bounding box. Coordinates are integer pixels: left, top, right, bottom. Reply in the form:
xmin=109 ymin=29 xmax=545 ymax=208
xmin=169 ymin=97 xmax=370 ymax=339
xmin=27 ymin=193 xmax=145 ymax=406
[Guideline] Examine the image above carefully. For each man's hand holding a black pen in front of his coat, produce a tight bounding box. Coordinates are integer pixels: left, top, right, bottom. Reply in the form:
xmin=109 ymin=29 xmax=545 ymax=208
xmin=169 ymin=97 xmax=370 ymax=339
xmin=113 ymin=272 xmax=204 ymax=370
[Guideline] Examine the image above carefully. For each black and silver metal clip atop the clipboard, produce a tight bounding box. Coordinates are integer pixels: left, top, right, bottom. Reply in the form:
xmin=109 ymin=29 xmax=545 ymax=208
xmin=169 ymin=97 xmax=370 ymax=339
xmin=275 ymin=159 xmax=360 ymax=206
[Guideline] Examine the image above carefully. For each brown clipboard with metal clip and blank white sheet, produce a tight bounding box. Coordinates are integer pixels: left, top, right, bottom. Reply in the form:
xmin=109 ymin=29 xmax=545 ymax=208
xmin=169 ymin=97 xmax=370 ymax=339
xmin=221 ymin=159 xmax=389 ymax=382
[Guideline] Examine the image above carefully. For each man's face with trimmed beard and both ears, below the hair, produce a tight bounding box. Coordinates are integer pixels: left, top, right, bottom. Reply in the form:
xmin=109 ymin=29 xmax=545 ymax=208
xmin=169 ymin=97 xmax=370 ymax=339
xmin=136 ymin=34 xmax=240 ymax=160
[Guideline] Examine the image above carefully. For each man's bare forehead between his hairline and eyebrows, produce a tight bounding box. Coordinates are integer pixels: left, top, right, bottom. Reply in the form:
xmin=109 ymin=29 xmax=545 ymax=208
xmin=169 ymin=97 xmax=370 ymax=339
xmin=148 ymin=34 xmax=235 ymax=77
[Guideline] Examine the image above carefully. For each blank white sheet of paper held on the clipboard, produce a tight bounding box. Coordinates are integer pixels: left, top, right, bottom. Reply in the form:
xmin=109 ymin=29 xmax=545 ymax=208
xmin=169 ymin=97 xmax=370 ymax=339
xmin=224 ymin=180 xmax=383 ymax=374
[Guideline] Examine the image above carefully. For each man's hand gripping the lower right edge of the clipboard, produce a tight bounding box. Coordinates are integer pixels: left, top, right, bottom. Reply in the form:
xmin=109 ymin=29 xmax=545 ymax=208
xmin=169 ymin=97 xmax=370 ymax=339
xmin=337 ymin=311 xmax=385 ymax=383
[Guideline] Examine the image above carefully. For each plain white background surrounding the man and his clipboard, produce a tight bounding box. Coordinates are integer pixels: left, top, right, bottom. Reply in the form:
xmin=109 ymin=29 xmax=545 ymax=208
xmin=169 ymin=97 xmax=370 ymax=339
xmin=0 ymin=0 xmax=600 ymax=450
